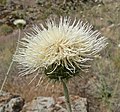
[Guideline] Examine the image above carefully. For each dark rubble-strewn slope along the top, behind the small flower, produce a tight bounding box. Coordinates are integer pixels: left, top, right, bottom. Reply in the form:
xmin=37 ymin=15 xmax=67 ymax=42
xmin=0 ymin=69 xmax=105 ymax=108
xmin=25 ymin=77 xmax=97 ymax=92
xmin=0 ymin=0 xmax=116 ymax=26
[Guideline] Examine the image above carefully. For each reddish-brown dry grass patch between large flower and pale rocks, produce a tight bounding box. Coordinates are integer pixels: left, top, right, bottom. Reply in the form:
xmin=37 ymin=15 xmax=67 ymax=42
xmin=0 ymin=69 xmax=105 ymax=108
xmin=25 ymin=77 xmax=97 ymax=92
xmin=5 ymin=77 xmax=63 ymax=102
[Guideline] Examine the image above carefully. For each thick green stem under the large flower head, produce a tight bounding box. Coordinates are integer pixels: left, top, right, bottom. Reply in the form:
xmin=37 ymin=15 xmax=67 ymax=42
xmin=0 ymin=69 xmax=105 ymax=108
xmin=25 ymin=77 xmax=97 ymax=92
xmin=62 ymin=80 xmax=72 ymax=112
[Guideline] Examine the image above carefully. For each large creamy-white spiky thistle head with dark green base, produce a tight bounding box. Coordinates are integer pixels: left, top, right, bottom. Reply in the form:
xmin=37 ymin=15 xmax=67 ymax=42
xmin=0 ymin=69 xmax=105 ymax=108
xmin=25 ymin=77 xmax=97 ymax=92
xmin=13 ymin=17 xmax=107 ymax=80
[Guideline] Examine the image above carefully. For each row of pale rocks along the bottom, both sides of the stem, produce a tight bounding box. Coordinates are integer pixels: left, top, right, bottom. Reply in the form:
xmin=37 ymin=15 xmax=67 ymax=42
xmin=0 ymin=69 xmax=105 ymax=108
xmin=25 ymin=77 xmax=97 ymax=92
xmin=0 ymin=92 xmax=87 ymax=112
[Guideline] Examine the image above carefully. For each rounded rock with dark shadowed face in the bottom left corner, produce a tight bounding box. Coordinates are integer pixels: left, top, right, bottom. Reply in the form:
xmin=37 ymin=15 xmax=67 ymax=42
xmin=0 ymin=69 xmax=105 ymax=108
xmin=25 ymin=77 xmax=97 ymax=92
xmin=0 ymin=92 xmax=25 ymax=112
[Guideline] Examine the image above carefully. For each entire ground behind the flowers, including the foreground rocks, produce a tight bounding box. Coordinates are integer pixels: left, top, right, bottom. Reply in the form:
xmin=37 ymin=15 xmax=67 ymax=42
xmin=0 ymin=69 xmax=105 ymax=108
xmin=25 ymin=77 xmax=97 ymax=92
xmin=0 ymin=0 xmax=120 ymax=112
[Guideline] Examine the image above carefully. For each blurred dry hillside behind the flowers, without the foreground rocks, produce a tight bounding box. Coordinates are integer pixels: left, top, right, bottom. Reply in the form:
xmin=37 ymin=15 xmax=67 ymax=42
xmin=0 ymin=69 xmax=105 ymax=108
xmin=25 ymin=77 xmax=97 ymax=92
xmin=0 ymin=0 xmax=120 ymax=112
